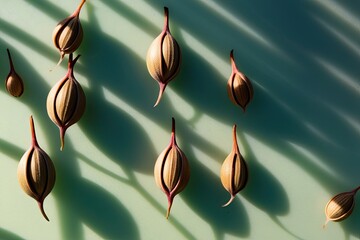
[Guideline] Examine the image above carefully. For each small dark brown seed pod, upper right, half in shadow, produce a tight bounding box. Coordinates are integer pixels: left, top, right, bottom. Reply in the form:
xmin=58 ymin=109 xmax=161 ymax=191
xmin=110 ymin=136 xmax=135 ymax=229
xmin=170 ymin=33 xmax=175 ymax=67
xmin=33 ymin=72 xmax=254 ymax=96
xmin=227 ymin=50 xmax=254 ymax=111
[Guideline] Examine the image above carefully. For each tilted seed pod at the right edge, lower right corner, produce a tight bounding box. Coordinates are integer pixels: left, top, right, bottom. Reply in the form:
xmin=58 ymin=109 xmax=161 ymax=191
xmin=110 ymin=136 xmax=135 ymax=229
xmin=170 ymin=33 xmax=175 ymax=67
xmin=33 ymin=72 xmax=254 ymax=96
xmin=323 ymin=186 xmax=360 ymax=227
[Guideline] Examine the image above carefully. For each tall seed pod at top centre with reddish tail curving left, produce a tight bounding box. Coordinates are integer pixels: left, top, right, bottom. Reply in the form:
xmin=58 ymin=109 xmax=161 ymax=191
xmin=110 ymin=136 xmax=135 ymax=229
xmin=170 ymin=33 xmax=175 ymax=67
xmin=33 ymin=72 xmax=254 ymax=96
xmin=146 ymin=7 xmax=181 ymax=107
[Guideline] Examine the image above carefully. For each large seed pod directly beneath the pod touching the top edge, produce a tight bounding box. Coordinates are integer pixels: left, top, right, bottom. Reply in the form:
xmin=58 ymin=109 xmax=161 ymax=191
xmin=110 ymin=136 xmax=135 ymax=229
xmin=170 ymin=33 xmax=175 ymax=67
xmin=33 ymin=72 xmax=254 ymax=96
xmin=46 ymin=53 xmax=86 ymax=150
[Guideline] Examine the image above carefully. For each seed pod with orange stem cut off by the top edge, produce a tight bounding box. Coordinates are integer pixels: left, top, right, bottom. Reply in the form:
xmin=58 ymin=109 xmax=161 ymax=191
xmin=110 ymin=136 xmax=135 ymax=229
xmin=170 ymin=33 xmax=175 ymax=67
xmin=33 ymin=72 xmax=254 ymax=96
xmin=53 ymin=0 xmax=86 ymax=64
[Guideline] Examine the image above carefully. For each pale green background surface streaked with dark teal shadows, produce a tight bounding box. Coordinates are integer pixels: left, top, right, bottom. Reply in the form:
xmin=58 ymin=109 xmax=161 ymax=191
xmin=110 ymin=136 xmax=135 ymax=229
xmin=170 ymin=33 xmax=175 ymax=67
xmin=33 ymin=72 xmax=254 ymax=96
xmin=0 ymin=0 xmax=360 ymax=240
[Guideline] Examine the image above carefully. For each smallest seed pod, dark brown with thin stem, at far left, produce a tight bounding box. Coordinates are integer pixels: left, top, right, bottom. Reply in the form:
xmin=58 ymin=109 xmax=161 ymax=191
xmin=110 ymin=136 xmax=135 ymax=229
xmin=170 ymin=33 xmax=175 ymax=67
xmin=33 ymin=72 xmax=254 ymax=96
xmin=5 ymin=49 xmax=24 ymax=97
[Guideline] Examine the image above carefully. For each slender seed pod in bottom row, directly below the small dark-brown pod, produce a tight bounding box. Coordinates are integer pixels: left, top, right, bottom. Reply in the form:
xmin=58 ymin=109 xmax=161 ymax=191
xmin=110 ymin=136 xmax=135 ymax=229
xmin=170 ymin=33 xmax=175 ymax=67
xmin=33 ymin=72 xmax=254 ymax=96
xmin=220 ymin=125 xmax=248 ymax=207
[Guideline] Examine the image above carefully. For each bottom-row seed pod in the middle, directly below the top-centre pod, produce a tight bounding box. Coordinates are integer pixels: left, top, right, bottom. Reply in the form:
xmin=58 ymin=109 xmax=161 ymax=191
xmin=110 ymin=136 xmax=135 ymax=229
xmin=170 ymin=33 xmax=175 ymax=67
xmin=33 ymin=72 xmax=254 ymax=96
xmin=154 ymin=118 xmax=190 ymax=218
